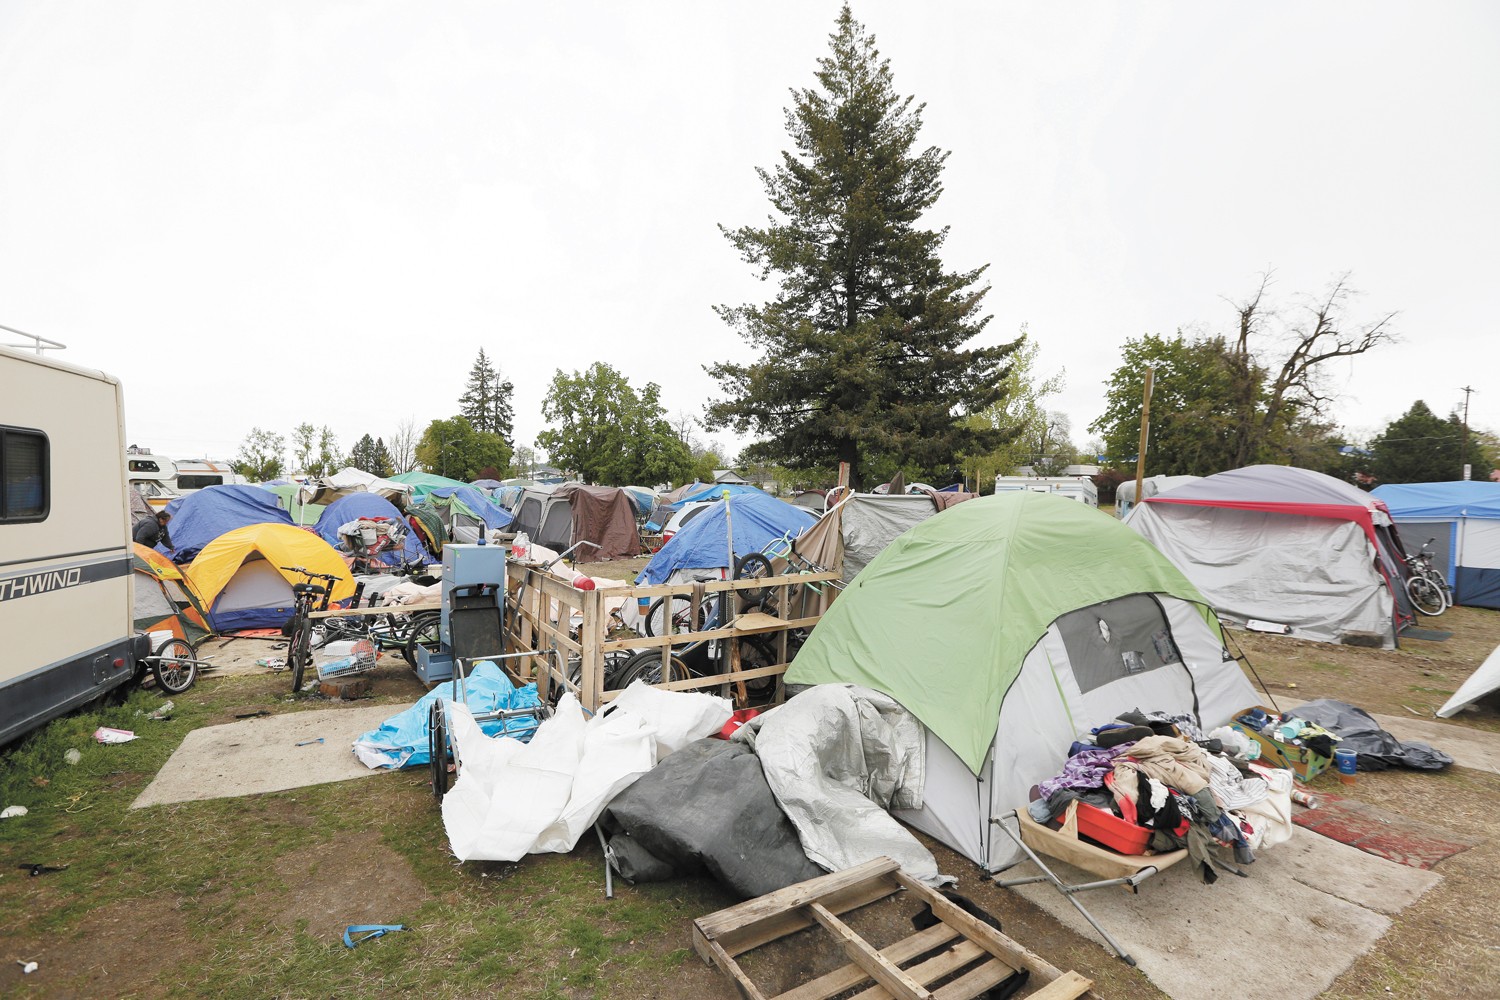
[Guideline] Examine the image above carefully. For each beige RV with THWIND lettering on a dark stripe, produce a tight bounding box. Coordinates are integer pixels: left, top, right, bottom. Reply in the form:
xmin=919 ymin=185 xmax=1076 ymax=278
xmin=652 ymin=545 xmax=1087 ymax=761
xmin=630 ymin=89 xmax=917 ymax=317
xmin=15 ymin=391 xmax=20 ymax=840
xmin=0 ymin=348 xmax=150 ymax=744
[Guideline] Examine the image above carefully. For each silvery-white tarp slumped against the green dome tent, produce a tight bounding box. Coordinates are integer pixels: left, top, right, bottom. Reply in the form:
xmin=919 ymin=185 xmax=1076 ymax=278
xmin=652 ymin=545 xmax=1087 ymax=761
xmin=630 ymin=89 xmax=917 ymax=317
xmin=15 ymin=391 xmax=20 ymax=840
xmin=734 ymin=684 xmax=953 ymax=886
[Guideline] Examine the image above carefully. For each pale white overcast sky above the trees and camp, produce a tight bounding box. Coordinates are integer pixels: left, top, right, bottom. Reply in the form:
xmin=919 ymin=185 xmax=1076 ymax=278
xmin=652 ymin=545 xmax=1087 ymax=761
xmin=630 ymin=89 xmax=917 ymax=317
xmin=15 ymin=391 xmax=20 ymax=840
xmin=0 ymin=0 xmax=1500 ymax=472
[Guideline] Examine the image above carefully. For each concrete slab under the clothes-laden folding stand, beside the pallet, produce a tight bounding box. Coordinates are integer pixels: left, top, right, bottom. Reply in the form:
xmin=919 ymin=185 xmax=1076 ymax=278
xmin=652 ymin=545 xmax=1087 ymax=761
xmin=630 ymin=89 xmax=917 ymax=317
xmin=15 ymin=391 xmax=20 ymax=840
xmin=1002 ymin=832 xmax=1442 ymax=1000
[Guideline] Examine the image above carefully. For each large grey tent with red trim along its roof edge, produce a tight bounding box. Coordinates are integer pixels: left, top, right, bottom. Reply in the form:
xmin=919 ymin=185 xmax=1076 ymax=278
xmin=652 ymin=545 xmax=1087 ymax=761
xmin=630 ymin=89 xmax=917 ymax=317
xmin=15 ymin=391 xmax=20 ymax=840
xmin=1124 ymin=465 xmax=1412 ymax=649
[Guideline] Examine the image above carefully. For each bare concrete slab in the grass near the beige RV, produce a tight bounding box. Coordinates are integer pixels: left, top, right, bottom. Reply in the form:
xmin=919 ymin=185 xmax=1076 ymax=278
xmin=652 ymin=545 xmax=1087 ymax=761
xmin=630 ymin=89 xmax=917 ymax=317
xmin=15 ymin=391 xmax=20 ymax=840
xmin=131 ymin=705 xmax=401 ymax=810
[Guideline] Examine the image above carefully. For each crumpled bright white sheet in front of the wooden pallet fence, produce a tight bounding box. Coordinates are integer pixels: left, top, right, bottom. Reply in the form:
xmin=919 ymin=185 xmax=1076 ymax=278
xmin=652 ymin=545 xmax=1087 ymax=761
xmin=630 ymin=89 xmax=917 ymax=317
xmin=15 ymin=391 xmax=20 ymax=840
xmin=443 ymin=682 xmax=731 ymax=861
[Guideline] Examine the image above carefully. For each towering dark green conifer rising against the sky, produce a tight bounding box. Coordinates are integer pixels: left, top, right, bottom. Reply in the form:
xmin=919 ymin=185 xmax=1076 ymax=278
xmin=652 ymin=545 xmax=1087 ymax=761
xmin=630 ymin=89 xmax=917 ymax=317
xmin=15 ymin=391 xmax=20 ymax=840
xmin=707 ymin=4 xmax=1016 ymax=484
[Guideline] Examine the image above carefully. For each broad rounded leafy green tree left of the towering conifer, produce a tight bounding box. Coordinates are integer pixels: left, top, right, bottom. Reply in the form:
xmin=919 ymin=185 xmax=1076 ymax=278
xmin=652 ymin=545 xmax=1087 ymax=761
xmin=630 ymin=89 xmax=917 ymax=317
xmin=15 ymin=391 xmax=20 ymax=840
xmin=537 ymin=361 xmax=693 ymax=486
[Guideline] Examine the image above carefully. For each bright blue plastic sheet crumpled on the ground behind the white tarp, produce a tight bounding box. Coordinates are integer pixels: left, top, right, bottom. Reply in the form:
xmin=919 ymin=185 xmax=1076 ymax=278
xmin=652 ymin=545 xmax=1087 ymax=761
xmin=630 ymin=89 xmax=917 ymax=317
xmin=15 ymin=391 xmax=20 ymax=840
xmin=354 ymin=660 xmax=542 ymax=769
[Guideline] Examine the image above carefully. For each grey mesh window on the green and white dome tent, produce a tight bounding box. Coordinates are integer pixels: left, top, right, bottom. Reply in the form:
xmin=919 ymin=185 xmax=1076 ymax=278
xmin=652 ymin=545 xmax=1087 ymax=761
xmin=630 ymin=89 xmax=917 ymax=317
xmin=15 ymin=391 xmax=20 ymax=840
xmin=1058 ymin=594 xmax=1182 ymax=693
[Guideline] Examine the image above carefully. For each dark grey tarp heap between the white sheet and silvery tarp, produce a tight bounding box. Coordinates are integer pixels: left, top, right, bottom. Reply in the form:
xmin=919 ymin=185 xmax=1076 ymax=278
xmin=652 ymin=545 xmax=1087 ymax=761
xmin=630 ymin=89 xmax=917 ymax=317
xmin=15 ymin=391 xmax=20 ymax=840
xmin=600 ymin=739 xmax=827 ymax=900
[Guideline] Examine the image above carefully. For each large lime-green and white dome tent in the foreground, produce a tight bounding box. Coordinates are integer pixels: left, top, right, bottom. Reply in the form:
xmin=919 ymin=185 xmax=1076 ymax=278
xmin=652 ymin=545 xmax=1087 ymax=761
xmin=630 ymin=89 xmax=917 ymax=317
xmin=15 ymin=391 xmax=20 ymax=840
xmin=786 ymin=492 xmax=1259 ymax=870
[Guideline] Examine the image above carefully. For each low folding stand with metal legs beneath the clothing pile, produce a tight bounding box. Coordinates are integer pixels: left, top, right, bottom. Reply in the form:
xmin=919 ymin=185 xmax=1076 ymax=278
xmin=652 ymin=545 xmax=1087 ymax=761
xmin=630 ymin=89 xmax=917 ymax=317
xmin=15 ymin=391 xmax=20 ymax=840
xmin=992 ymin=802 xmax=1188 ymax=966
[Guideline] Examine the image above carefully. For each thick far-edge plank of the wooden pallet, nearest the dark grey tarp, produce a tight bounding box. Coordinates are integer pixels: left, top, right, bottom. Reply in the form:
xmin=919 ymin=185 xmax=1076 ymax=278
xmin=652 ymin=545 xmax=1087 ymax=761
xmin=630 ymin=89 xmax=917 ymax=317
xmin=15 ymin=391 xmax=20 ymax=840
xmin=693 ymin=858 xmax=899 ymax=955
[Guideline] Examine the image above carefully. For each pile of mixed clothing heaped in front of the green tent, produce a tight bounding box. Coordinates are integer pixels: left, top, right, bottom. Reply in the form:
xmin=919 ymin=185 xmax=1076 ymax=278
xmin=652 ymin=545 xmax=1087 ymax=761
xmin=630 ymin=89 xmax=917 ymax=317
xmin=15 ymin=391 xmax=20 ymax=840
xmin=1028 ymin=711 xmax=1293 ymax=883
